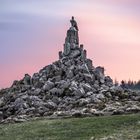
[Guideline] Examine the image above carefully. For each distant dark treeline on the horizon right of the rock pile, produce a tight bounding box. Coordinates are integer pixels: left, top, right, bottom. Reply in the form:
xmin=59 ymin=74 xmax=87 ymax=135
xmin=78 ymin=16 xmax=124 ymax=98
xmin=115 ymin=80 xmax=140 ymax=90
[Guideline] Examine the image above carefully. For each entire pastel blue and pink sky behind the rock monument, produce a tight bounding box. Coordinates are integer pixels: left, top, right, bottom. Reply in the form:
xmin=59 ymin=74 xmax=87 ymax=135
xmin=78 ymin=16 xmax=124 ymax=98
xmin=0 ymin=0 xmax=140 ymax=88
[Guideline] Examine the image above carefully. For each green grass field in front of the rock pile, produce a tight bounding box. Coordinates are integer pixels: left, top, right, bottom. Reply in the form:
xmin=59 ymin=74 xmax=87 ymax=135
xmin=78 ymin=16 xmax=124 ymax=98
xmin=0 ymin=114 xmax=140 ymax=140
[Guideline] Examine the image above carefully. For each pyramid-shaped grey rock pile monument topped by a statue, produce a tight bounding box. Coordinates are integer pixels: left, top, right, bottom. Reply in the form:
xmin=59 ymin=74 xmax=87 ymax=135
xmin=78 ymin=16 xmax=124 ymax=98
xmin=0 ymin=17 xmax=140 ymax=122
